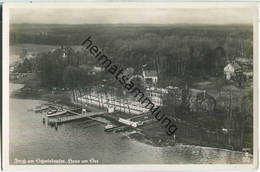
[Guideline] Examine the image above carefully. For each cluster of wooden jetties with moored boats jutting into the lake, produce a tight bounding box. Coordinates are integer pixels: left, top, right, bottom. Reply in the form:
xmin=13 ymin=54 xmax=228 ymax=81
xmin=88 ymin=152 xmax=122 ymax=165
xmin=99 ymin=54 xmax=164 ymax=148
xmin=39 ymin=105 xmax=149 ymax=132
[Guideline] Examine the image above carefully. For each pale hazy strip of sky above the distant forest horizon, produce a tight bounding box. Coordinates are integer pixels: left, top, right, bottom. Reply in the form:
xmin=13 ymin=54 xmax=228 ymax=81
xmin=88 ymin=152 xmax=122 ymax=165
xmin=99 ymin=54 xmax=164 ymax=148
xmin=10 ymin=7 xmax=253 ymax=25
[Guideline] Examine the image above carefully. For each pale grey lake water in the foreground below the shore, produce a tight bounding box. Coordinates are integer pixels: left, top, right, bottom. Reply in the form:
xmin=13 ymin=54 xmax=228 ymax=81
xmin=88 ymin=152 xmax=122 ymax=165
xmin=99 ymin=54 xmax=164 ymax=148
xmin=10 ymin=84 xmax=251 ymax=164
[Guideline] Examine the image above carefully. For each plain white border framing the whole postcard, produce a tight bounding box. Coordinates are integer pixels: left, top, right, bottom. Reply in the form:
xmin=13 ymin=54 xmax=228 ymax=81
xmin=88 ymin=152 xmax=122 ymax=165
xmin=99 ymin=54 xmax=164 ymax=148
xmin=2 ymin=2 xmax=258 ymax=171
